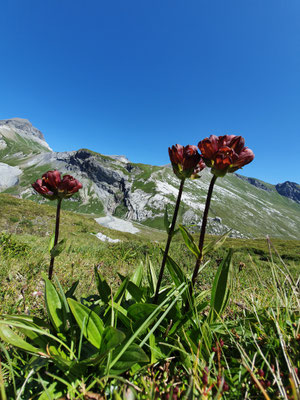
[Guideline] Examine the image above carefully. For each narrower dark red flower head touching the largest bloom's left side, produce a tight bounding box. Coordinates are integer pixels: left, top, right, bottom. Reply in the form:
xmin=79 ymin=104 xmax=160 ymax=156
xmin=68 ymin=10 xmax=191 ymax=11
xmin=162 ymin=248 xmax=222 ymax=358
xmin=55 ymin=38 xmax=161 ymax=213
xmin=169 ymin=144 xmax=205 ymax=179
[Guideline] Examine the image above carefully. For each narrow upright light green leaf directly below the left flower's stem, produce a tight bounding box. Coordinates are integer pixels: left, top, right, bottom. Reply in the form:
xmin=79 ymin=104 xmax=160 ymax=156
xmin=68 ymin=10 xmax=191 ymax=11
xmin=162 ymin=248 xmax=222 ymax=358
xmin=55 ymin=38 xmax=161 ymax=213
xmin=44 ymin=278 xmax=66 ymax=332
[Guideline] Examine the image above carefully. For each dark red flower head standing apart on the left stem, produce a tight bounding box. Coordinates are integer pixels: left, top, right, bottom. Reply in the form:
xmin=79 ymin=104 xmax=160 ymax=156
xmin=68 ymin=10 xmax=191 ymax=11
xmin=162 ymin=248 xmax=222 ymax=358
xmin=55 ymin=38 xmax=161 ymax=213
xmin=32 ymin=170 xmax=82 ymax=200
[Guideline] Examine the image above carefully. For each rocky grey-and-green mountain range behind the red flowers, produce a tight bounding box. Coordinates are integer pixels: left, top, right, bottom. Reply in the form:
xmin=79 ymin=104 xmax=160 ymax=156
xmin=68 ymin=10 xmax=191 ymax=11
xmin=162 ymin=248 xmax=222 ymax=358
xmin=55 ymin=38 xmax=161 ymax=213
xmin=0 ymin=118 xmax=300 ymax=239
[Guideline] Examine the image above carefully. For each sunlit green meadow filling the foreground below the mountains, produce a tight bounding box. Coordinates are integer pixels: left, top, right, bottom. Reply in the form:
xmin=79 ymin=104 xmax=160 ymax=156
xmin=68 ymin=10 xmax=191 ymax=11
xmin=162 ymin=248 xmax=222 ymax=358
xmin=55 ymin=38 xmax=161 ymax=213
xmin=0 ymin=194 xmax=300 ymax=399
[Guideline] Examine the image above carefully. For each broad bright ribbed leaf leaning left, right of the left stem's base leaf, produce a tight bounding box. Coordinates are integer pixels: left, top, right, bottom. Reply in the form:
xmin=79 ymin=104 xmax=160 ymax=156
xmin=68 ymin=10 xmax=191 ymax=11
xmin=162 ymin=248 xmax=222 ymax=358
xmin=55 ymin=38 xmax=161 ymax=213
xmin=68 ymin=299 xmax=104 ymax=349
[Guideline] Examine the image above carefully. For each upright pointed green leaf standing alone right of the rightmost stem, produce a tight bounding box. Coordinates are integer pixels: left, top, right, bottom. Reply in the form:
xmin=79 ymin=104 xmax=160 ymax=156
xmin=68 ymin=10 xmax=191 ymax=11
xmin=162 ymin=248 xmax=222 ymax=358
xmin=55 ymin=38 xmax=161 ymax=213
xmin=208 ymin=249 xmax=233 ymax=322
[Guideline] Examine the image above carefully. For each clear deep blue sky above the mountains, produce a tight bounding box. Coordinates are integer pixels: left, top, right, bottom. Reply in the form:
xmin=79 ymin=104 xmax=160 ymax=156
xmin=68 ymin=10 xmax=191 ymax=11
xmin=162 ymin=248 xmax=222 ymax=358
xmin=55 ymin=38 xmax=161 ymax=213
xmin=0 ymin=0 xmax=300 ymax=183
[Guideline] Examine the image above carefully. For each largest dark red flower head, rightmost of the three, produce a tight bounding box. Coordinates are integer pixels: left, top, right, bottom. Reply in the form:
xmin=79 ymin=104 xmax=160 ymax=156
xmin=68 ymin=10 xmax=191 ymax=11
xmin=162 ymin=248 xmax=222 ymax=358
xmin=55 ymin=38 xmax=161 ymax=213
xmin=198 ymin=135 xmax=254 ymax=176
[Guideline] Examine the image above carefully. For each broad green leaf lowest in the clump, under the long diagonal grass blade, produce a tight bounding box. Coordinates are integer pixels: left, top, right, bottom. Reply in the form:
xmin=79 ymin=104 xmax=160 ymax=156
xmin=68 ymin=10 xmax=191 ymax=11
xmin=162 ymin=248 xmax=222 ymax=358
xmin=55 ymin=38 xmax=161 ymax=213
xmin=111 ymin=343 xmax=149 ymax=374
